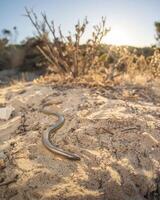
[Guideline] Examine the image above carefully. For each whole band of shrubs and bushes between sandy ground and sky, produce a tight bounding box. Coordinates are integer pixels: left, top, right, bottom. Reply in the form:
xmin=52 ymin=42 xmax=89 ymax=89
xmin=0 ymin=8 xmax=160 ymax=83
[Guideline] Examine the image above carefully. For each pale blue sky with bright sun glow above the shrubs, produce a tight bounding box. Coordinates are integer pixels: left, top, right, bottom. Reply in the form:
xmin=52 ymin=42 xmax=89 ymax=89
xmin=0 ymin=0 xmax=160 ymax=47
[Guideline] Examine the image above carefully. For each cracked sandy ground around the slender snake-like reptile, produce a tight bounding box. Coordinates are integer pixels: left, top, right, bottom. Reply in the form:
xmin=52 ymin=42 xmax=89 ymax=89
xmin=0 ymin=83 xmax=160 ymax=200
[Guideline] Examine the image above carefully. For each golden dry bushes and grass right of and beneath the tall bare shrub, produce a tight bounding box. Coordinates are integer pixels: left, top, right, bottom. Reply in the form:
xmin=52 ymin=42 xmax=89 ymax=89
xmin=36 ymin=46 xmax=160 ymax=86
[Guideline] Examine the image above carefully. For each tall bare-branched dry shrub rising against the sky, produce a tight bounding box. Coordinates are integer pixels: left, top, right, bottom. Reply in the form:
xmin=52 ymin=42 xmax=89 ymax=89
xmin=26 ymin=8 xmax=112 ymax=77
